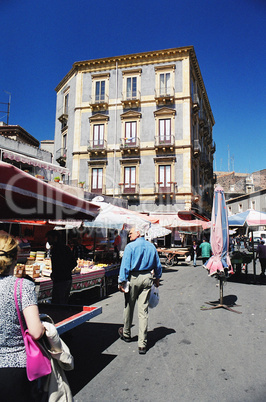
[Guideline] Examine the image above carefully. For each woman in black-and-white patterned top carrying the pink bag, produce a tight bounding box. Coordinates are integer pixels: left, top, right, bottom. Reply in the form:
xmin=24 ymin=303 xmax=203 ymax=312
xmin=0 ymin=232 xmax=44 ymax=402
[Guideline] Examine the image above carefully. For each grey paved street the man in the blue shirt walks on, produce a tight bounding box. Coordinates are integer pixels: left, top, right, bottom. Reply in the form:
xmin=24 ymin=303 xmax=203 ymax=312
xmin=63 ymin=262 xmax=266 ymax=402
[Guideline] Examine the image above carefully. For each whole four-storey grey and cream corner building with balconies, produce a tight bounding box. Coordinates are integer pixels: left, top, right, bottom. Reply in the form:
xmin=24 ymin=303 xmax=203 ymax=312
xmin=54 ymin=46 xmax=215 ymax=214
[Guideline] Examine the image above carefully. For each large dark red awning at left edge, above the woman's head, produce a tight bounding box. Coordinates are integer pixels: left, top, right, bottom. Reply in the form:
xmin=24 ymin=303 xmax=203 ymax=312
xmin=0 ymin=162 xmax=99 ymax=220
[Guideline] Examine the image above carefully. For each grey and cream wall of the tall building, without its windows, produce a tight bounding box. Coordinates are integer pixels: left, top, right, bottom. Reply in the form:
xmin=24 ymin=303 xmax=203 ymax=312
xmin=55 ymin=47 xmax=214 ymax=212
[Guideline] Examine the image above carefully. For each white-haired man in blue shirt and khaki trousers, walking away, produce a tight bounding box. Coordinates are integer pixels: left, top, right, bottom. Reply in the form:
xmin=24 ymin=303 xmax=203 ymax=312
xmin=118 ymin=225 xmax=162 ymax=354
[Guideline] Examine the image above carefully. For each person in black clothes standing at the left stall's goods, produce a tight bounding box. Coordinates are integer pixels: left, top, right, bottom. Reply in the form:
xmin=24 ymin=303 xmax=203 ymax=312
xmin=46 ymin=230 xmax=77 ymax=304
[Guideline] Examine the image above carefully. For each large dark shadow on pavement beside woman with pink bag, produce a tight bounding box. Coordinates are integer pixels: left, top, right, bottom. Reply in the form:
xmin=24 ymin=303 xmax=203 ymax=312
xmin=62 ymin=322 xmax=120 ymax=395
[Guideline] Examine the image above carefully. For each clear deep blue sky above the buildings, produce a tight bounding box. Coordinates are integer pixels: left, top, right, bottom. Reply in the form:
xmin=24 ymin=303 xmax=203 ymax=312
xmin=0 ymin=0 xmax=266 ymax=172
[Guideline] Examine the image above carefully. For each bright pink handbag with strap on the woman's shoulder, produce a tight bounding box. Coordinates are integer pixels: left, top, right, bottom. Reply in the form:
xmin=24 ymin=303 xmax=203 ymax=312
xmin=14 ymin=279 xmax=51 ymax=381
